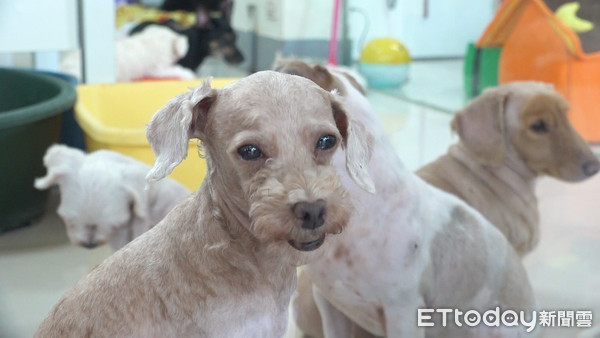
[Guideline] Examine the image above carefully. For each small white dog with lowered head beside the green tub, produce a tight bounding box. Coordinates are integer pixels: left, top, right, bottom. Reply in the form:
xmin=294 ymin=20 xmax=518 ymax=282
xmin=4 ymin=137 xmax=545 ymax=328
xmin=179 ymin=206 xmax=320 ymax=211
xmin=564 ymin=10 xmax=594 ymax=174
xmin=34 ymin=145 xmax=190 ymax=251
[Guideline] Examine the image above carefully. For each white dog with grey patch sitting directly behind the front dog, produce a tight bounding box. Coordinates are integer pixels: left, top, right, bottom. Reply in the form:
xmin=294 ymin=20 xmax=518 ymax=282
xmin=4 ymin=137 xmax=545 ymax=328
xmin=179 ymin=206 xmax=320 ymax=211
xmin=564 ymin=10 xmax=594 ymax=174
xmin=276 ymin=61 xmax=535 ymax=338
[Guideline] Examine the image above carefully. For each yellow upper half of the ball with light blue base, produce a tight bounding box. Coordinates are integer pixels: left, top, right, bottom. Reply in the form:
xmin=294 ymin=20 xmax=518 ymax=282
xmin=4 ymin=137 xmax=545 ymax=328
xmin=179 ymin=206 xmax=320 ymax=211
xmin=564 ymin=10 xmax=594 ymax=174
xmin=360 ymin=38 xmax=410 ymax=64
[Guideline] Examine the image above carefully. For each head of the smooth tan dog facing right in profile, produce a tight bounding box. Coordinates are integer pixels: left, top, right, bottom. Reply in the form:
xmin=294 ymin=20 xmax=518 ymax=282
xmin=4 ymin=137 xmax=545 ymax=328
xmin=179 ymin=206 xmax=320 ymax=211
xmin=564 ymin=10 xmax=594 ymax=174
xmin=452 ymin=82 xmax=600 ymax=181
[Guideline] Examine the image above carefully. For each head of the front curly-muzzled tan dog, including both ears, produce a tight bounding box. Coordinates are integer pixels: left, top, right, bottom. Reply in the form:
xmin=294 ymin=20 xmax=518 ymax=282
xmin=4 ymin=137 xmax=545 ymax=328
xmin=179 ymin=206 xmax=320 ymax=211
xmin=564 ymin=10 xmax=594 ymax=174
xmin=148 ymin=71 xmax=373 ymax=251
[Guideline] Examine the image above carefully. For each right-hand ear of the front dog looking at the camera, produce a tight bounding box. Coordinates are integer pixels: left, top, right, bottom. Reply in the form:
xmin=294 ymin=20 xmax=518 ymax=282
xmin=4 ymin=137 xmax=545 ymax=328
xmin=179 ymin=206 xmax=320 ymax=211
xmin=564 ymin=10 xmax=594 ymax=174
xmin=331 ymin=95 xmax=375 ymax=194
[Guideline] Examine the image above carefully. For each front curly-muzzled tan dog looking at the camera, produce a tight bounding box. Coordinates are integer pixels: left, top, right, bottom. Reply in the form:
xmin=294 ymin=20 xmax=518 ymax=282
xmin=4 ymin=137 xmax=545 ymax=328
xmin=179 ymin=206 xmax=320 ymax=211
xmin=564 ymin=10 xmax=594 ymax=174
xmin=37 ymin=71 xmax=373 ymax=337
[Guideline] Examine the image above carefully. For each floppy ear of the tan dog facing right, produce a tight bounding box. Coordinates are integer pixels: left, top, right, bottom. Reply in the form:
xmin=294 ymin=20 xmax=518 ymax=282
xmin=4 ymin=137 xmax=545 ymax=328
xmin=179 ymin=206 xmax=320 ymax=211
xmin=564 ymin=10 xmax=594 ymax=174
xmin=450 ymin=89 xmax=506 ymax=167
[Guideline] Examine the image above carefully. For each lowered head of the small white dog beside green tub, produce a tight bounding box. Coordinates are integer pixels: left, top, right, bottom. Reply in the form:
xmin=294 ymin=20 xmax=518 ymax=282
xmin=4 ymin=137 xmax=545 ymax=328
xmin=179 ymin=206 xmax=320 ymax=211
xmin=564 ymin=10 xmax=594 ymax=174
xmin=35 ymin=145 xmax=143 ymax=249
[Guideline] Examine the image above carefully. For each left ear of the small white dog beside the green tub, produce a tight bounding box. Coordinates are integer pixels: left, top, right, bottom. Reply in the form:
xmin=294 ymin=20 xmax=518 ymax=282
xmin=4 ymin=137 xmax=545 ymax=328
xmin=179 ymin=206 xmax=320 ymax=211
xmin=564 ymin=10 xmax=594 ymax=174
xmin=33 ymin=144 xmax=85 ymax=190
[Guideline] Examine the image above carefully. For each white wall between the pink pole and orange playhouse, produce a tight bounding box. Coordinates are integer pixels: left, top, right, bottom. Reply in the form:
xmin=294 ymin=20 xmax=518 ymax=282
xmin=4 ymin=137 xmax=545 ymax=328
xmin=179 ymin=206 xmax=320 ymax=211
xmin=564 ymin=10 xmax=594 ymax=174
xmin=348 ymin=0 xmax=496 ymax=58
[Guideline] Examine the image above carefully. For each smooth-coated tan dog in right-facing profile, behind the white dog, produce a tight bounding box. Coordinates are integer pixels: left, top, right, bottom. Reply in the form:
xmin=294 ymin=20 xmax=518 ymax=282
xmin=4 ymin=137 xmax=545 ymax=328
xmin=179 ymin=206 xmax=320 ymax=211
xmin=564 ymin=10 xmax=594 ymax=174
xmin=417 ymin=82 xmax=600 ymax=256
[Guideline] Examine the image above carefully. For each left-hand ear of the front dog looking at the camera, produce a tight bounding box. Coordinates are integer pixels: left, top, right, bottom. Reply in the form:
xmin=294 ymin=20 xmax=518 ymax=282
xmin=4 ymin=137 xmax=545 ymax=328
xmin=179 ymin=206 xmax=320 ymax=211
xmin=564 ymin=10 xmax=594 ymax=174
xmin=146 ymin=79 xmax=217 ymax=182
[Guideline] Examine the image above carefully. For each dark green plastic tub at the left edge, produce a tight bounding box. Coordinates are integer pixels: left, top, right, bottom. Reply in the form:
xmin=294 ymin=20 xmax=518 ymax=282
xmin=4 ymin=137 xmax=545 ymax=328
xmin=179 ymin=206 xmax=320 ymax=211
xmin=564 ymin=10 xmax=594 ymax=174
xmin=0 ymin=68 xmax=77 ymax=233
